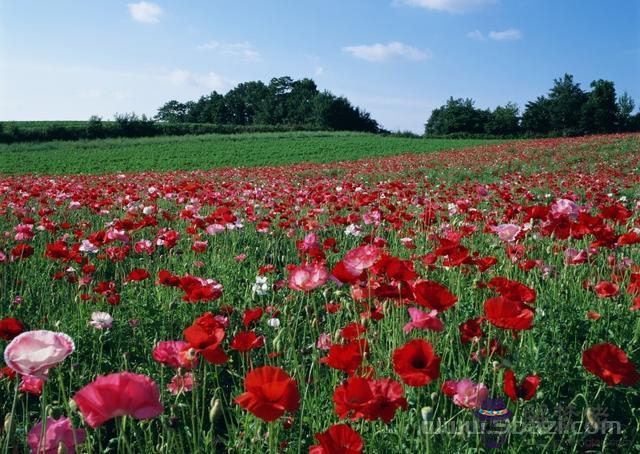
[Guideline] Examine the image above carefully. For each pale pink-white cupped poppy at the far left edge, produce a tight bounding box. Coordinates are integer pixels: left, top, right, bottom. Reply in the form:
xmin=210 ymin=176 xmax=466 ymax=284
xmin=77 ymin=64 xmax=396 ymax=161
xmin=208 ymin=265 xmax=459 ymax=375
xmin=4 ymin=330 xmax=75 ymax=378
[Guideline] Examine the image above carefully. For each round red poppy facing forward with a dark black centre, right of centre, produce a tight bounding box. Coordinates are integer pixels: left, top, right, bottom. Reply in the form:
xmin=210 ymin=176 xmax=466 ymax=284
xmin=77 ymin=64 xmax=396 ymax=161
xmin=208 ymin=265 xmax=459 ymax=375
xmin=393 ymin=339 xmax=440 ymax=386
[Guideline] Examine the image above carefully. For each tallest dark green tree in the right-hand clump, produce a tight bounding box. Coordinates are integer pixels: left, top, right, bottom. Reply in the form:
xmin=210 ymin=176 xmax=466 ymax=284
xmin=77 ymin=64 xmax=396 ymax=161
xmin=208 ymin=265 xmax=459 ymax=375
xmin=548 ymin=74 xmax=587 ymax=135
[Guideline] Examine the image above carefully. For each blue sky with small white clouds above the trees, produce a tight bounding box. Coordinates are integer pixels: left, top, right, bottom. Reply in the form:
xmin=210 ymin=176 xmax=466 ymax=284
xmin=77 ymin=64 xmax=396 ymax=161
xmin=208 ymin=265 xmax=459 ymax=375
xmin=0 ymin=0 xmax=640 ymax=132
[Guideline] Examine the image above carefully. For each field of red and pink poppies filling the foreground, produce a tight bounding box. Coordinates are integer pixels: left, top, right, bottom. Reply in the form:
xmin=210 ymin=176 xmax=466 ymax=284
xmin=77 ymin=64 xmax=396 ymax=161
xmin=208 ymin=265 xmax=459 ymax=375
xmin=0 ymin=134 xmax=640 ymax=454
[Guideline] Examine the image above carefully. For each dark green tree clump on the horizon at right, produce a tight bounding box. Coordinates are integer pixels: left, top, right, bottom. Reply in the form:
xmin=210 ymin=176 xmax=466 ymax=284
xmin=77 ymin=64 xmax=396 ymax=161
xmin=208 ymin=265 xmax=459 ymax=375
xmin=425 ymin=74 xmax=640 ymax=137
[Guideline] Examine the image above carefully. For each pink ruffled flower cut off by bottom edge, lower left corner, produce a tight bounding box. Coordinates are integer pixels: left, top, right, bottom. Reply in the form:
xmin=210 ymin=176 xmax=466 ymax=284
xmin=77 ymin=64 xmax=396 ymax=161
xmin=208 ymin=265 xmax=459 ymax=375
xmin=27 ymin=416 xmax=86 ymax=454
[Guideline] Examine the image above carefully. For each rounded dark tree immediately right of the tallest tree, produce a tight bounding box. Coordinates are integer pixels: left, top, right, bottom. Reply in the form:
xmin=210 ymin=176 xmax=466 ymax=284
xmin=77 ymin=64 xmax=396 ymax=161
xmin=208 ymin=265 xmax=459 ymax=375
xmin=580 ymin=79 xmax=620 ymax=133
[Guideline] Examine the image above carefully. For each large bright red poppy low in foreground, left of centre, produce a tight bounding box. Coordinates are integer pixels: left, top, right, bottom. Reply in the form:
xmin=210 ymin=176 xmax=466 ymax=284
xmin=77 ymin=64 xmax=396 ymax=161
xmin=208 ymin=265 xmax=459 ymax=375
xmin=234 ymin=366 xmax=300 ymax=422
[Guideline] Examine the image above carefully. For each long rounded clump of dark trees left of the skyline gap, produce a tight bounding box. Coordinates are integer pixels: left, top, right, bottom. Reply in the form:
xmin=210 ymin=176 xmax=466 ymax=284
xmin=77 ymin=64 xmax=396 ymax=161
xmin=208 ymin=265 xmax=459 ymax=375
xmin=155 ymin=76 xmax=380 ymax=133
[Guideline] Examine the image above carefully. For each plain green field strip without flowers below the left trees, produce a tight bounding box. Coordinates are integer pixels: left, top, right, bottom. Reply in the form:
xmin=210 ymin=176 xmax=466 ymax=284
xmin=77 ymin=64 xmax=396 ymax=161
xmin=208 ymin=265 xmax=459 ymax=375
xmin=0 ymin=132 xmax=499 ymax=174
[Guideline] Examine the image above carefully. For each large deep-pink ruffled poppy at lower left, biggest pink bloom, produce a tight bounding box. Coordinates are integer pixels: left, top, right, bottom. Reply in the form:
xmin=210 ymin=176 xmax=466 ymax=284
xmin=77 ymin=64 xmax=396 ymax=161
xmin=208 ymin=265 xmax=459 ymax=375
xmin=73 ymin=372 xmax=164 ymax=429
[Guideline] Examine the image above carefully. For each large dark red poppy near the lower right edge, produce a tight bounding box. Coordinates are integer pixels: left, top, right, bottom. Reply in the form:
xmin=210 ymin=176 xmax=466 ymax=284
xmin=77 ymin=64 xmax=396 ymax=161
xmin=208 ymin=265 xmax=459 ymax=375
xmin=582 ymin=343 xmax=640 ymax=386
